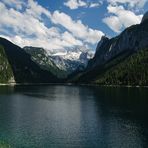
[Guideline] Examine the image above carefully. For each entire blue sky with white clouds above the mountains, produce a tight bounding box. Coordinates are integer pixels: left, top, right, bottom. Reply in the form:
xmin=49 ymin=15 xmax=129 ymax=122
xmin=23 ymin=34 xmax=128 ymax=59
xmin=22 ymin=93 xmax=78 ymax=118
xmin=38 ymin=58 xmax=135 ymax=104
xmin=0 ymin=0 xmax=148 ymax=51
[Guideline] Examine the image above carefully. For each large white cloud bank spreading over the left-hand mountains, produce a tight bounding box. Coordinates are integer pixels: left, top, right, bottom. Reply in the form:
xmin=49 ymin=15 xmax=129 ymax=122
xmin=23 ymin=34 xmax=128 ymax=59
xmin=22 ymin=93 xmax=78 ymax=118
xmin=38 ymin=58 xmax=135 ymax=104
xmin=0 ymin=3 xmax=82 ymax=49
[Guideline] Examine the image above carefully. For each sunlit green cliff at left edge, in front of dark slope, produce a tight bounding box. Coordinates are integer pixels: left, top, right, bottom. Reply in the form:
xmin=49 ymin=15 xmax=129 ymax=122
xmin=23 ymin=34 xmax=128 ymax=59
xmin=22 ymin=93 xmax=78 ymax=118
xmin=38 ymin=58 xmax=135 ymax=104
xmin=0 ymin=46 xmax=15 ymax=83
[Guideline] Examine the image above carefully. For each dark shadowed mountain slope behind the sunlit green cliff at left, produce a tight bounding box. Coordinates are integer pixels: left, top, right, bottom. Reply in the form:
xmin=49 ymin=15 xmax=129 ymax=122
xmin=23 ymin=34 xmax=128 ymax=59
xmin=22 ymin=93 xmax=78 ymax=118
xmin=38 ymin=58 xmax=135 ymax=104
xmin=0 ymin=38 xmax=58 ymax=83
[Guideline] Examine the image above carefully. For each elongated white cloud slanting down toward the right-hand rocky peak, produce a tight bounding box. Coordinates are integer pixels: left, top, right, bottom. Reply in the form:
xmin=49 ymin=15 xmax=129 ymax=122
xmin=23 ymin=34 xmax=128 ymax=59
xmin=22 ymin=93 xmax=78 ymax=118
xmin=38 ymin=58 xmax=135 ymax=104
xmin=51 ymin=11 xmax=103 ymax=44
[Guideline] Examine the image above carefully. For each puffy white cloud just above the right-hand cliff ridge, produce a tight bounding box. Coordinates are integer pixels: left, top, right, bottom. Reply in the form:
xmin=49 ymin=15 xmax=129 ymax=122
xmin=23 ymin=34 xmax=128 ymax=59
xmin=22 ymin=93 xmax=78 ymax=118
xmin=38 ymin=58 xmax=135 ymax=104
xmin=103 ymin=5 xmax=142 ymax=33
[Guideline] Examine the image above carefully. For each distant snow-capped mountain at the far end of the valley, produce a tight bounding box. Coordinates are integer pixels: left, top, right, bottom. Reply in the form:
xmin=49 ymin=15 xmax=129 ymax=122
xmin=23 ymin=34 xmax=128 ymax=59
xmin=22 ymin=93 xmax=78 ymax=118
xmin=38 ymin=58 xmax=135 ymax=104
xmin=49 ymin=47 xmax=94 ymax=74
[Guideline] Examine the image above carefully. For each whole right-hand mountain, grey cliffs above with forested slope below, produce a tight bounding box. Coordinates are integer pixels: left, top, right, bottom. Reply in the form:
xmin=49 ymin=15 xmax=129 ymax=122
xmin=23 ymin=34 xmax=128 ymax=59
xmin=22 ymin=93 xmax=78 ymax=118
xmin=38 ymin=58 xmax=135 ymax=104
xmin=69 ymin=15 xmax=148 ymax=85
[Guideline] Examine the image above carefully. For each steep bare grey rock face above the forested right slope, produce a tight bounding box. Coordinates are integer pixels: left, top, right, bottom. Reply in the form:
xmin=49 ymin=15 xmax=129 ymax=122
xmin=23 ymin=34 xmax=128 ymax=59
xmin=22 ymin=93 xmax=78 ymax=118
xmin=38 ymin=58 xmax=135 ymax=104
xmin=88 ymin=20 xmax=148 ymax=69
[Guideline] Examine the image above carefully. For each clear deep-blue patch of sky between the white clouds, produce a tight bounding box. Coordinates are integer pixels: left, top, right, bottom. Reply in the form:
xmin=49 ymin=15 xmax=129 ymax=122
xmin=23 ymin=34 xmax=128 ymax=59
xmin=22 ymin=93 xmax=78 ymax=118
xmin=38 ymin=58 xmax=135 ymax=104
xmin=38 ymin=0 xmax=116 ymax=36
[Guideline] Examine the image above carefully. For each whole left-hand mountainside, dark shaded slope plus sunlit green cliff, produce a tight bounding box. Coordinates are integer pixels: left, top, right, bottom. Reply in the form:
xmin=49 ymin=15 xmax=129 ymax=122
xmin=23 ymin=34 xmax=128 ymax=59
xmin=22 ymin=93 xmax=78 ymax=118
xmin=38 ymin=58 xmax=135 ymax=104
xmin=0 ymin=38 xmax=59 ymax=83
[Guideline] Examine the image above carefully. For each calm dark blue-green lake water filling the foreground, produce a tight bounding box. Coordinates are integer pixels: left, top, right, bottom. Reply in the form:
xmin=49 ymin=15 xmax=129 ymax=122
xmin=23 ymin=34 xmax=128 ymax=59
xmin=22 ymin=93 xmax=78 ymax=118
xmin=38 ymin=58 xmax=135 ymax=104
xmin=0 ymin=85 xmax=148 ymax=148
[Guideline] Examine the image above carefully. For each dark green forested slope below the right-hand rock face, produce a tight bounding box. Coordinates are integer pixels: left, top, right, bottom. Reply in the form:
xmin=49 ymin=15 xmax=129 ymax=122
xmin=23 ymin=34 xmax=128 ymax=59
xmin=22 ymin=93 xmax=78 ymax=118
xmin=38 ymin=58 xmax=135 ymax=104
xmin=93 ymin=49 xmax=148 ymax=86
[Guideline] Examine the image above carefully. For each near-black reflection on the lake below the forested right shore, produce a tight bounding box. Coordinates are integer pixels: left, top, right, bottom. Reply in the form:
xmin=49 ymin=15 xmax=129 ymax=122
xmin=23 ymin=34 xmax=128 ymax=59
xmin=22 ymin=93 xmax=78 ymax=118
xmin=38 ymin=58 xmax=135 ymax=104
xmin=93 ymin=87 xmax=148 ymax=112
